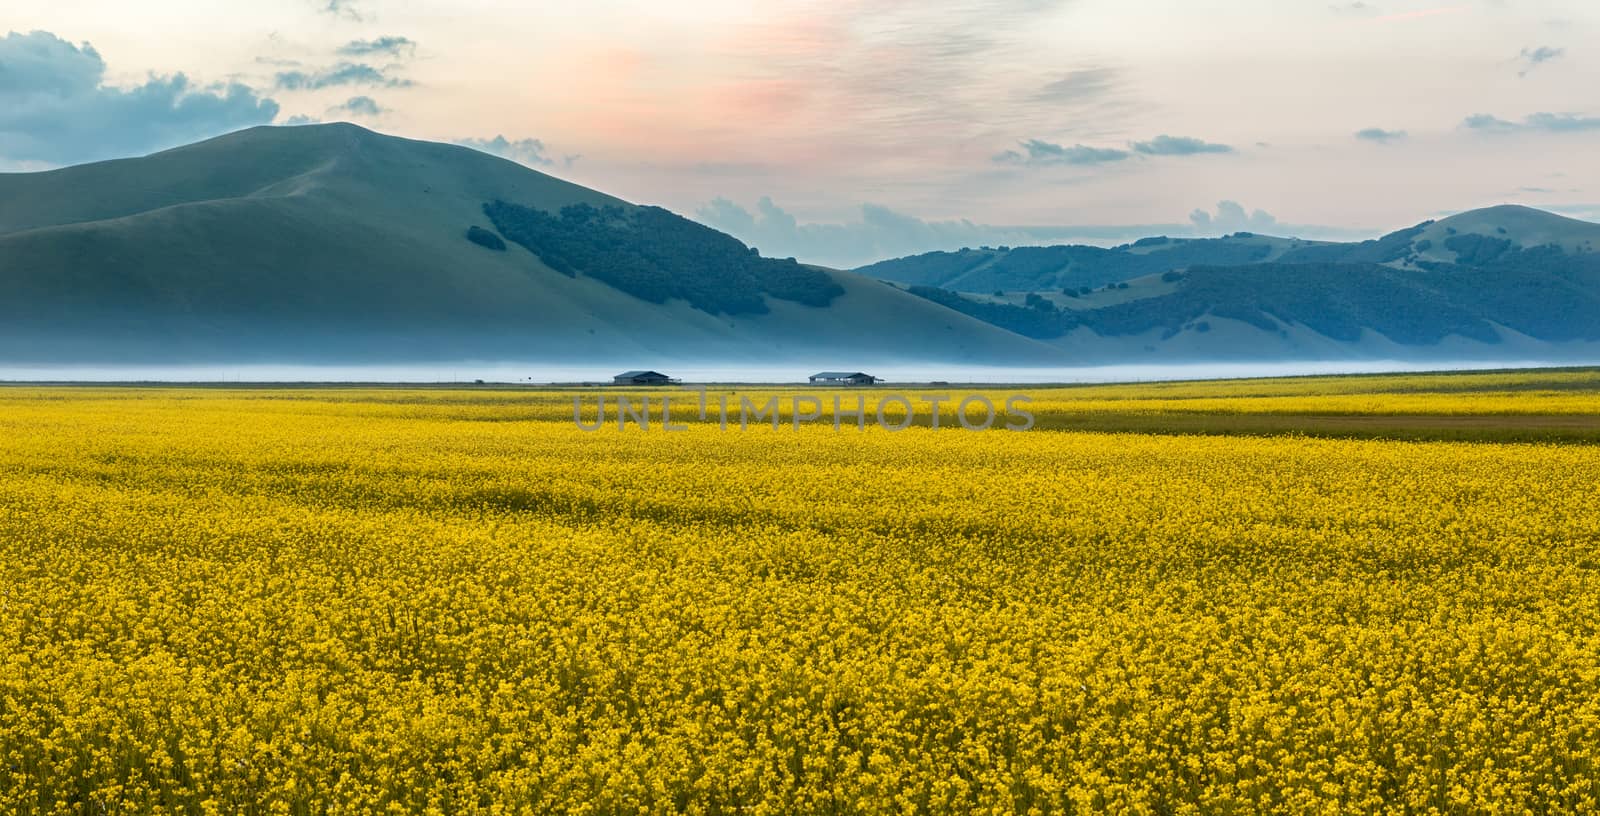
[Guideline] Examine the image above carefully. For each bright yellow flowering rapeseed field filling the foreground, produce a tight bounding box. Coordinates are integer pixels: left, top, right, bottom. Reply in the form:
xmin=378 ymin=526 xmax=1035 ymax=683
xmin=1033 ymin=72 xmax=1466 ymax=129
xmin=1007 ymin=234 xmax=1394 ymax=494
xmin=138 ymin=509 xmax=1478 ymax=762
xmin=0 ymin=382 xmax=1600 ymax=814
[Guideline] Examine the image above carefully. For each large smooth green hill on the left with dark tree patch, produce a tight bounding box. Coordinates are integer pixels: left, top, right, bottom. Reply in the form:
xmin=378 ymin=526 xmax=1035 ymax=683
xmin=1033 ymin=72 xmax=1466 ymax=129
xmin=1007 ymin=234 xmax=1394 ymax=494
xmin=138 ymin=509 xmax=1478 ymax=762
xmin=0 ymin=125 xmax=1064 ymax=365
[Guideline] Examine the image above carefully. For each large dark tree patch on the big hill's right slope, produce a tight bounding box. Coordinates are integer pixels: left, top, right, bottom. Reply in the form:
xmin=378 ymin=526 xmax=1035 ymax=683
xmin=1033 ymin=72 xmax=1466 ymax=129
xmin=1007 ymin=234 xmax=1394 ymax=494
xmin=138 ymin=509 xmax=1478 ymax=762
xmin=483 ymin=202 xmax=845 ymax=315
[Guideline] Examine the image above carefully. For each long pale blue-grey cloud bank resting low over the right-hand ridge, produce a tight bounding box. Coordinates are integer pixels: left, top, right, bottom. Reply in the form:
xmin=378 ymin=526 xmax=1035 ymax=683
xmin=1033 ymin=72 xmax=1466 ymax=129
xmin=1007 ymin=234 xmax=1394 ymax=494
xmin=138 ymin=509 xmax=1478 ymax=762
xmin=694 ymin=197 xmax=1374 ymax=269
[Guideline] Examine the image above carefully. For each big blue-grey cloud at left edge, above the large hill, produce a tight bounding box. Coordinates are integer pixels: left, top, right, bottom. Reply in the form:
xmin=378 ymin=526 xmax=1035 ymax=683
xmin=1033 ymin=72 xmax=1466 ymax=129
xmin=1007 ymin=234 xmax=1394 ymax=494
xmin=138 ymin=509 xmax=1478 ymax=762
xmin=0 ymin=30 xmax=278 ymax=165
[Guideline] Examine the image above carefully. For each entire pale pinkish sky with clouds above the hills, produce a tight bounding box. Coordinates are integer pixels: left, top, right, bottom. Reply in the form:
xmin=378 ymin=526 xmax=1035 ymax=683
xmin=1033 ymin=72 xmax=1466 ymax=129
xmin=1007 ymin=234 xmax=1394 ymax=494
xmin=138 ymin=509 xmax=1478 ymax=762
xmin=0 ymin=0 xmax=1600 ymax=266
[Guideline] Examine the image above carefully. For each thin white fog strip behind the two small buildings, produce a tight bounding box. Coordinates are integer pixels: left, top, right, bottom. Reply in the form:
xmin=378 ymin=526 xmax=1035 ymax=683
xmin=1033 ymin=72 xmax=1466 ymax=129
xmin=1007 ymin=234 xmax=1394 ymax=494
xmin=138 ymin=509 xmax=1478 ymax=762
xmin=0 ymin=360 xmax=1581 ymax=386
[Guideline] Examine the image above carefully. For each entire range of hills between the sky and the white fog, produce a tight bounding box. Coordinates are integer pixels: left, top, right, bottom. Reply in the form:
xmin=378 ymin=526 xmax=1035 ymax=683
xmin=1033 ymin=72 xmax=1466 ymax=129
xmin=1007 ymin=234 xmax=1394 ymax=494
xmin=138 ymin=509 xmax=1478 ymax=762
xmin=0 ymin=125 xmax=1600 ymax=366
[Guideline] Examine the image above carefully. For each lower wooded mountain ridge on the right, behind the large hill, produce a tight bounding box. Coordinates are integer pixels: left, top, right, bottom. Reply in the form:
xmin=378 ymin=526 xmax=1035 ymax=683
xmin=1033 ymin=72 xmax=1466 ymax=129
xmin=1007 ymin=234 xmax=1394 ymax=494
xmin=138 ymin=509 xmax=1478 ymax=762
xmin=861 ymin=206 xmax=1600 ymax=358
